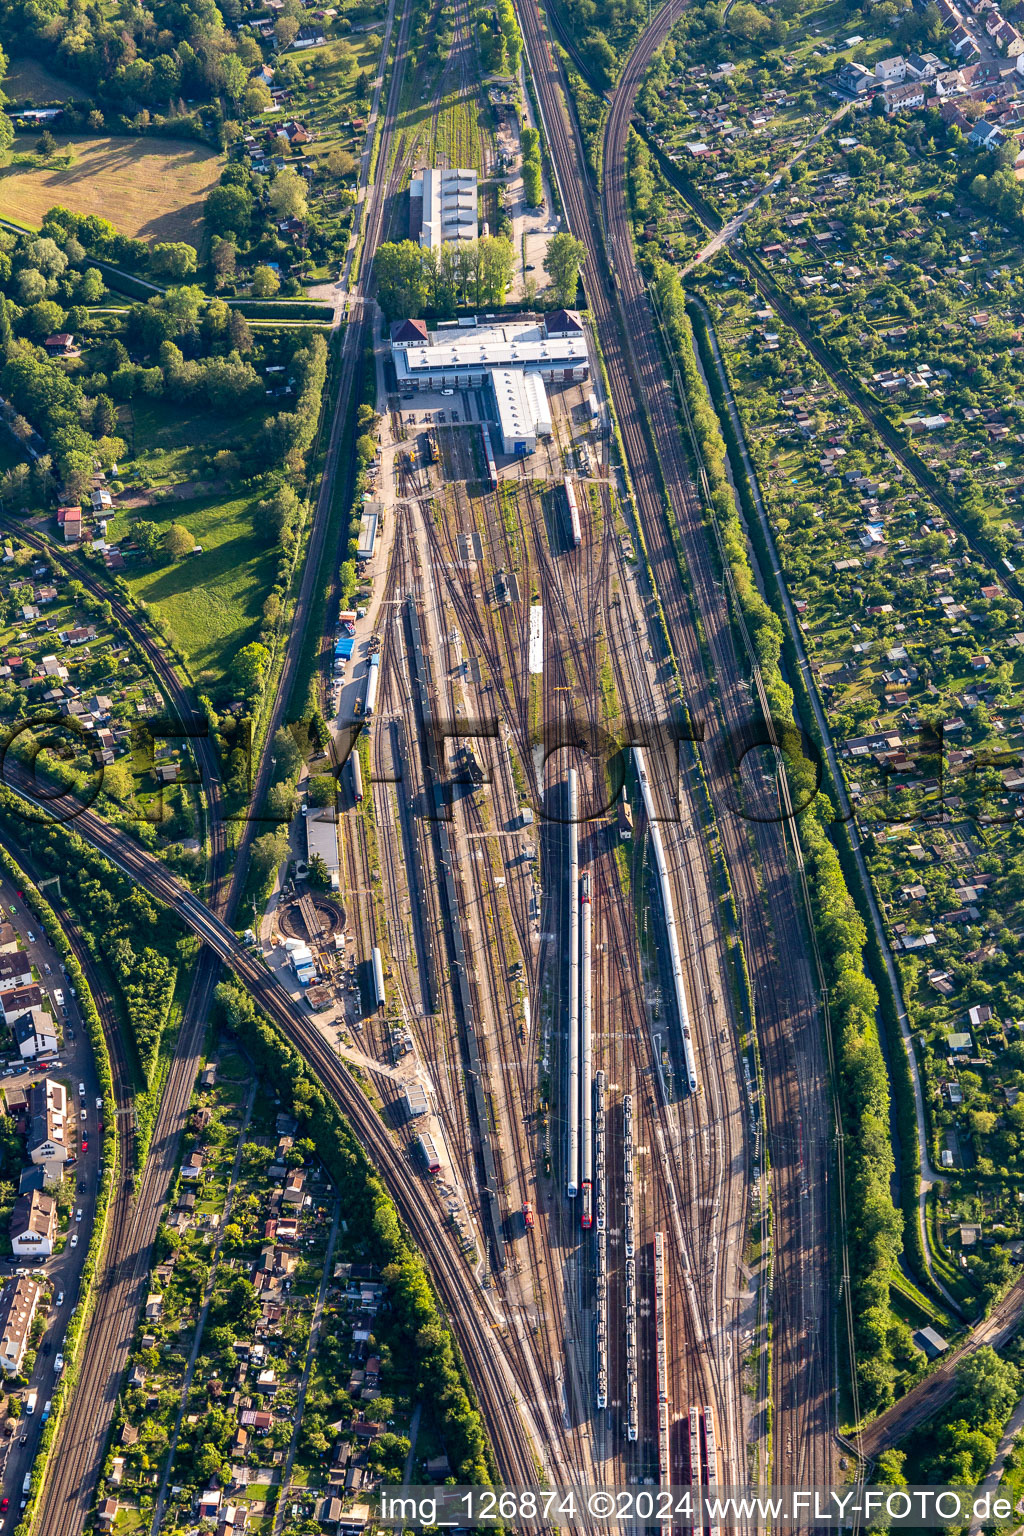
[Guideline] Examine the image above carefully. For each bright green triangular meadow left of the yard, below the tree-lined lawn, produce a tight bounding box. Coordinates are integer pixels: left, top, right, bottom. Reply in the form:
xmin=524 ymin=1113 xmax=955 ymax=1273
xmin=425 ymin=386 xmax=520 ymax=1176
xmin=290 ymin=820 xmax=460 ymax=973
xmin=111 ymin=496 xmax=275 ymax=688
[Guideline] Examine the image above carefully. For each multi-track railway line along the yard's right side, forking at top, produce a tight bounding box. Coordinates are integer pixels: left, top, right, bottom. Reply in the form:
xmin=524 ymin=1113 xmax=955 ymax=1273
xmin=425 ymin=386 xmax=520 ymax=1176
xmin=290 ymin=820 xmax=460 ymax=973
xmin=519 ymin=0 xmax=835 ymax=1481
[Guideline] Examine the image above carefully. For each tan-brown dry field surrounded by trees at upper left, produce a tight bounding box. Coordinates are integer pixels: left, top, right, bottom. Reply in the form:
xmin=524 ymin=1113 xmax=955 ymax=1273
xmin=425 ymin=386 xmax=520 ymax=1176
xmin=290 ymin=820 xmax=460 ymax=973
xmin=0 ymin=134 xmax=221 ymax=247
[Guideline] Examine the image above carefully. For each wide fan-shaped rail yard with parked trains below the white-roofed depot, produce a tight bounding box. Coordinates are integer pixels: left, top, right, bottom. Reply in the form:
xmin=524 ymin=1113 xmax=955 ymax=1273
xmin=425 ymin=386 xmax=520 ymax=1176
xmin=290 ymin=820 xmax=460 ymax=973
xmin=316 ymin=356 xmax=771 ymax=1484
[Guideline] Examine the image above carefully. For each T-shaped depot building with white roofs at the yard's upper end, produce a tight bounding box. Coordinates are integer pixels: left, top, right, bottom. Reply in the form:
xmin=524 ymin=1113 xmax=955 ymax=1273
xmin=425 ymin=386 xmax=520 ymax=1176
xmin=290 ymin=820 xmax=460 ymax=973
xmin=391 ymin=309 xmax=590 ymax=456
